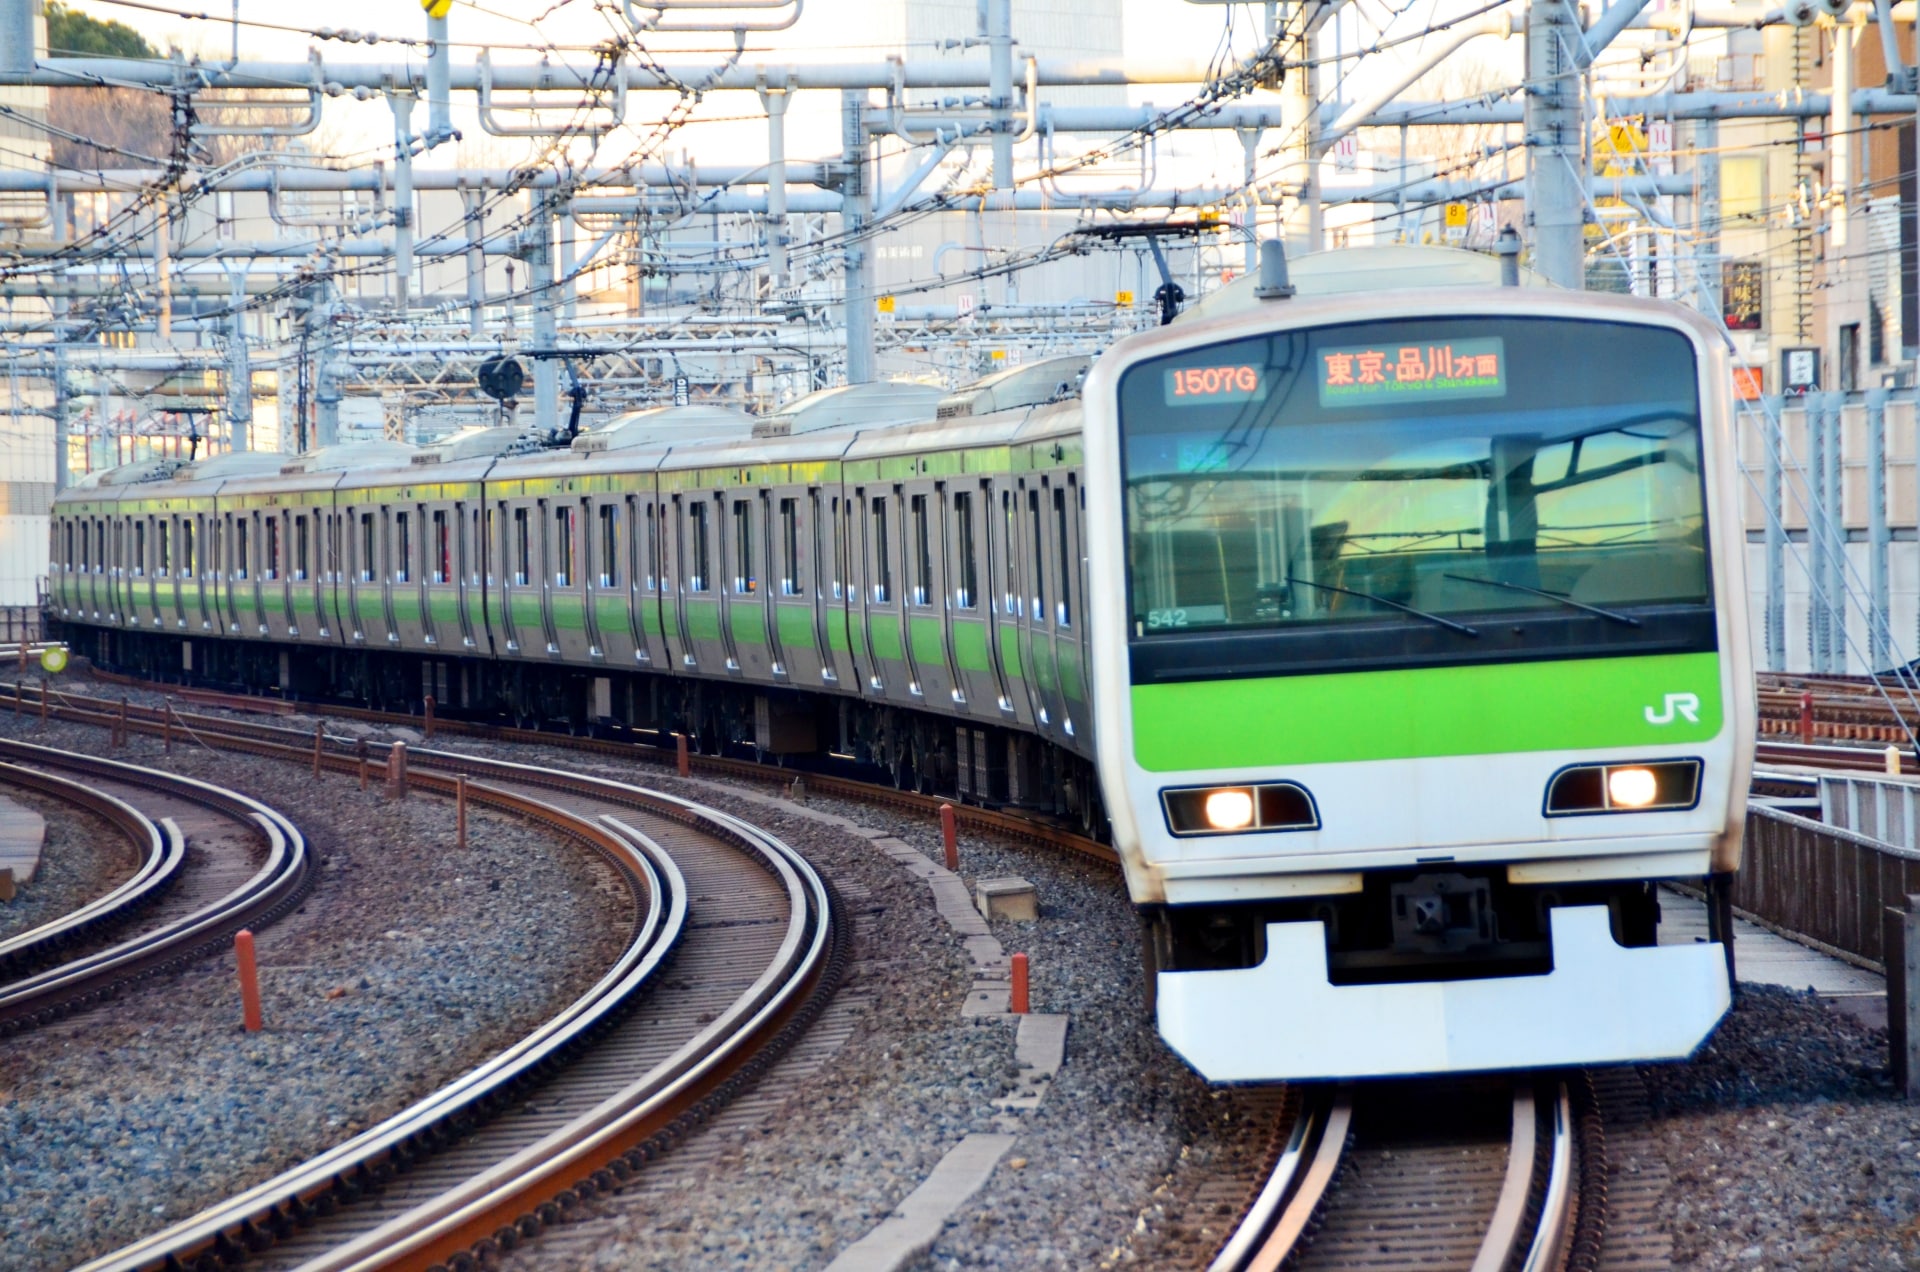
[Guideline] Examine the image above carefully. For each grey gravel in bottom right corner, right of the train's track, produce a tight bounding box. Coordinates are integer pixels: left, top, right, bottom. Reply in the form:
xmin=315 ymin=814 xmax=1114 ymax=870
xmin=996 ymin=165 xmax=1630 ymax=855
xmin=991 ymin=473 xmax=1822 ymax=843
xmin=1645 ymin=986 xmax=1920 ymax=1272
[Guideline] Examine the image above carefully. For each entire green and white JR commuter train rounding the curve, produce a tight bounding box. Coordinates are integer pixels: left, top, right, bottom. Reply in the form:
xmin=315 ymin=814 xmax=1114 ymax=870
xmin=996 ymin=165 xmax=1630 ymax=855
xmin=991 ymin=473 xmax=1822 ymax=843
xmin=50 ymin=250 xmax=1755 ymax=1082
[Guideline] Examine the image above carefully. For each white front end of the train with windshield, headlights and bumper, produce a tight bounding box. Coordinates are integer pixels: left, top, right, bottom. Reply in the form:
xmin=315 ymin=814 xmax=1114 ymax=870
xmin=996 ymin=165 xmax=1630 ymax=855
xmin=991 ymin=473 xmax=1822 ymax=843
xmin=1085 ymin=288 xmax=1755 ymax=1082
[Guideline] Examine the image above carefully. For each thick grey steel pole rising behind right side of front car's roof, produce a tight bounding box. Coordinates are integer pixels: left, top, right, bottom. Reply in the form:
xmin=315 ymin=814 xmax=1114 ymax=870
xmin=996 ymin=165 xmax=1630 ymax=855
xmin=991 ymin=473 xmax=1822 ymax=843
xmin=1523 ymin=0 xmax=1586 ymax=290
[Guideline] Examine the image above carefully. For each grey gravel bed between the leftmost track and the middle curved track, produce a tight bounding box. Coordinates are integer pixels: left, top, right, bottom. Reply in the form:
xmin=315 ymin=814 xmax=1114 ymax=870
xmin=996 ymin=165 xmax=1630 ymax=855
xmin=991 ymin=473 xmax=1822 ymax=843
xmin=0 ymin=713 xmax=630 ymax=1268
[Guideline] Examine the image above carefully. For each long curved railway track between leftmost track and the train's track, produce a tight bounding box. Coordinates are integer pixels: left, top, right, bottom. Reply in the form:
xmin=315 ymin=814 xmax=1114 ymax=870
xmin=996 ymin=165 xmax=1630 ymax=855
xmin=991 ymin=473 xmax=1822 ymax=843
xmin=11 ymin=699 xmax=847 ymax=1272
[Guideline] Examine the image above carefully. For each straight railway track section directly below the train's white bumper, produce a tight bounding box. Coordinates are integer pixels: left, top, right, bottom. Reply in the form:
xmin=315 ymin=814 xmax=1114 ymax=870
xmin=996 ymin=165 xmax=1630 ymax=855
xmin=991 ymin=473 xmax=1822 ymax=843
xmin=1208 ymin=1074 xmax=1596 ymax=1272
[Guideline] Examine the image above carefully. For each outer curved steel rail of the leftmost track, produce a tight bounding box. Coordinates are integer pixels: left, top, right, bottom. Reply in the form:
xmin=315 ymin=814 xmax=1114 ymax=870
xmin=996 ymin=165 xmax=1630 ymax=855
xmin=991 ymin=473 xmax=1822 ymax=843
xmin=0 ymin=740 xmax=311 ymax=1034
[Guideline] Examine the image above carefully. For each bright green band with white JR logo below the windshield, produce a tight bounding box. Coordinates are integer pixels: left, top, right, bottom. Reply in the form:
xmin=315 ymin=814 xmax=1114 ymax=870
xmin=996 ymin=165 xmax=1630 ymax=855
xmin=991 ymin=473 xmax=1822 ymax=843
xmin=1133 ymin=653 xmax=1722 ymax=772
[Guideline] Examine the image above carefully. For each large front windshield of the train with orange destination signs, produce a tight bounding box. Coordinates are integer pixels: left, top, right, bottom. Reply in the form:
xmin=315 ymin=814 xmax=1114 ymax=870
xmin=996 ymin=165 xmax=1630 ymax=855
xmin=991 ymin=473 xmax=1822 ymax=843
xmin=1119 ymin=317 xmax=1711 ymax=674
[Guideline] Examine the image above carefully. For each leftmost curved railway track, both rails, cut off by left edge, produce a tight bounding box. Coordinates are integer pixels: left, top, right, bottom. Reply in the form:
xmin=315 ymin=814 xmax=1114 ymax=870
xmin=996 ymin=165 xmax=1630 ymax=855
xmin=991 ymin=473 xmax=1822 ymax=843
xmin=0 ymin=740 xmax=311 ymax=1036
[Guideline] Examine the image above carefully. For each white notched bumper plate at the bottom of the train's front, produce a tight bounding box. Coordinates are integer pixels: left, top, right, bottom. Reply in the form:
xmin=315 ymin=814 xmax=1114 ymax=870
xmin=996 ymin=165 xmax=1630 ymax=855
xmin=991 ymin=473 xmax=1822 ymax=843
xmin=1158 ymin=905 xmax=1732 ymax=1082
